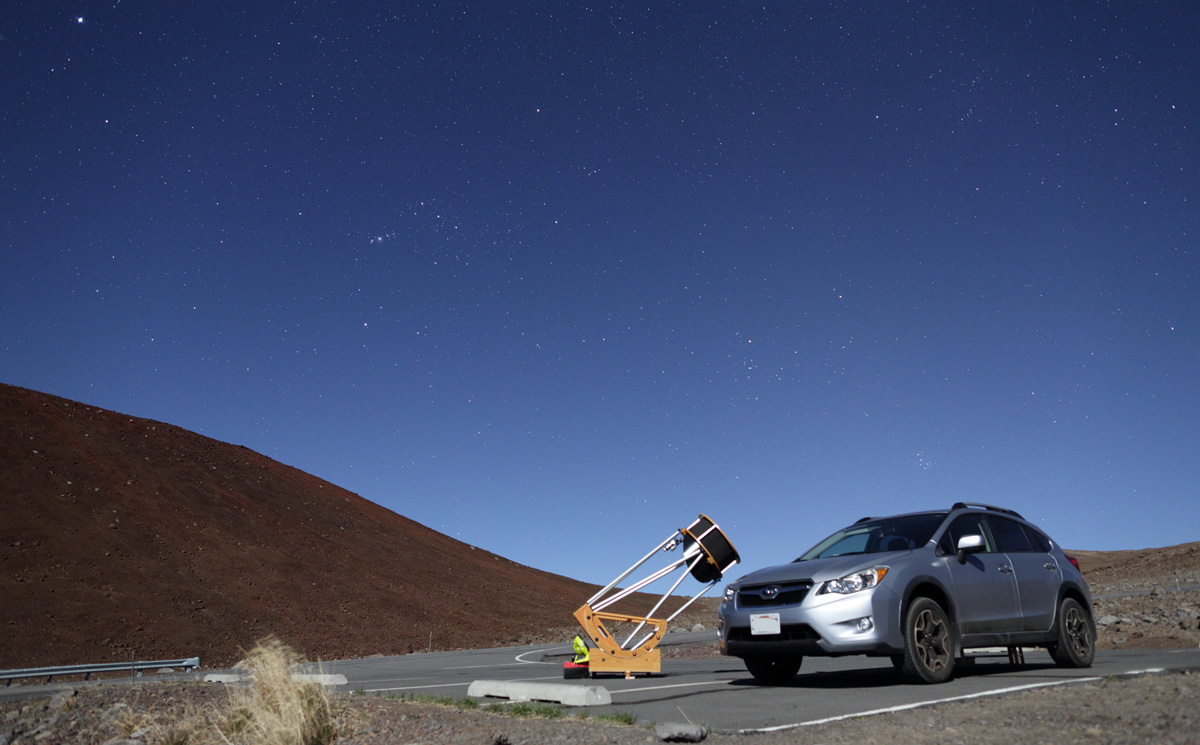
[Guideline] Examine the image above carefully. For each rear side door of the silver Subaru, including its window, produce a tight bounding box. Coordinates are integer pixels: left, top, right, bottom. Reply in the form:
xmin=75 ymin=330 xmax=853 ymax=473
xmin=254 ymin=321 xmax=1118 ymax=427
xmin=986 ymin=515 xmax=1062 ymax=631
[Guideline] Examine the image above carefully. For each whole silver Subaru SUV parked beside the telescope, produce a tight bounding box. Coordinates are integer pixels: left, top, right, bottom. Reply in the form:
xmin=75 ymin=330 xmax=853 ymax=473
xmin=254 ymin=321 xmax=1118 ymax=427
xmin=718 ymin=503 xmax=1096 ymax=684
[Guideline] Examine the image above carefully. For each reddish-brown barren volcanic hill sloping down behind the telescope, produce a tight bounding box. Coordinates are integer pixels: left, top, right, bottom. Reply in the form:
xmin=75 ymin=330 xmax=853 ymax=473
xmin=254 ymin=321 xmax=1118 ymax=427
xmin=0 ymin=384 xmax=595 ymax=669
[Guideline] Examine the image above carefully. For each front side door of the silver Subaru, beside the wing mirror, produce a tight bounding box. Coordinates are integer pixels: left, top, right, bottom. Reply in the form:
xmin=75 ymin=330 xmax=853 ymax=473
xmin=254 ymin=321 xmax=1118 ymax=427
xmin=938 ymin=515 xmax=1021 ymax=633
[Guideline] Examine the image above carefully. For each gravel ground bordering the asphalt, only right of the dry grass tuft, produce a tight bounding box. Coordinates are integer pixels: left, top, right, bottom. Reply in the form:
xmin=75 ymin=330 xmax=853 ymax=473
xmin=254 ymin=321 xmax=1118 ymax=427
xmin=328 ymin=674 xmax=1200 ymax=745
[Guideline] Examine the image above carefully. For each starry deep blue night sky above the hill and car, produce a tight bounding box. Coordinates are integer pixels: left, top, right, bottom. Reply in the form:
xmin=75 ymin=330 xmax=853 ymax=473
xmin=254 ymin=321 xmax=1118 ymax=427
xmin=0 ymin=0 xmax=1200 ymax=590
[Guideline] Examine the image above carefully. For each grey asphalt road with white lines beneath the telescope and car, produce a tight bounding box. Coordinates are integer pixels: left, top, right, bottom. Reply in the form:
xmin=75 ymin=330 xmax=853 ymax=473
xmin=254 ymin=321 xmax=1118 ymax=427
xmin=323 ymin=632 xmax=1200 ymax=732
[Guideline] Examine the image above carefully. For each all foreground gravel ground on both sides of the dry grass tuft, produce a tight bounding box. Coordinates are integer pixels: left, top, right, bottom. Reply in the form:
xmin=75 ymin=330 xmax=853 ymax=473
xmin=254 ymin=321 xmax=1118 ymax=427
xmin=0 ymin=673 xmax=1200 ymax=745
